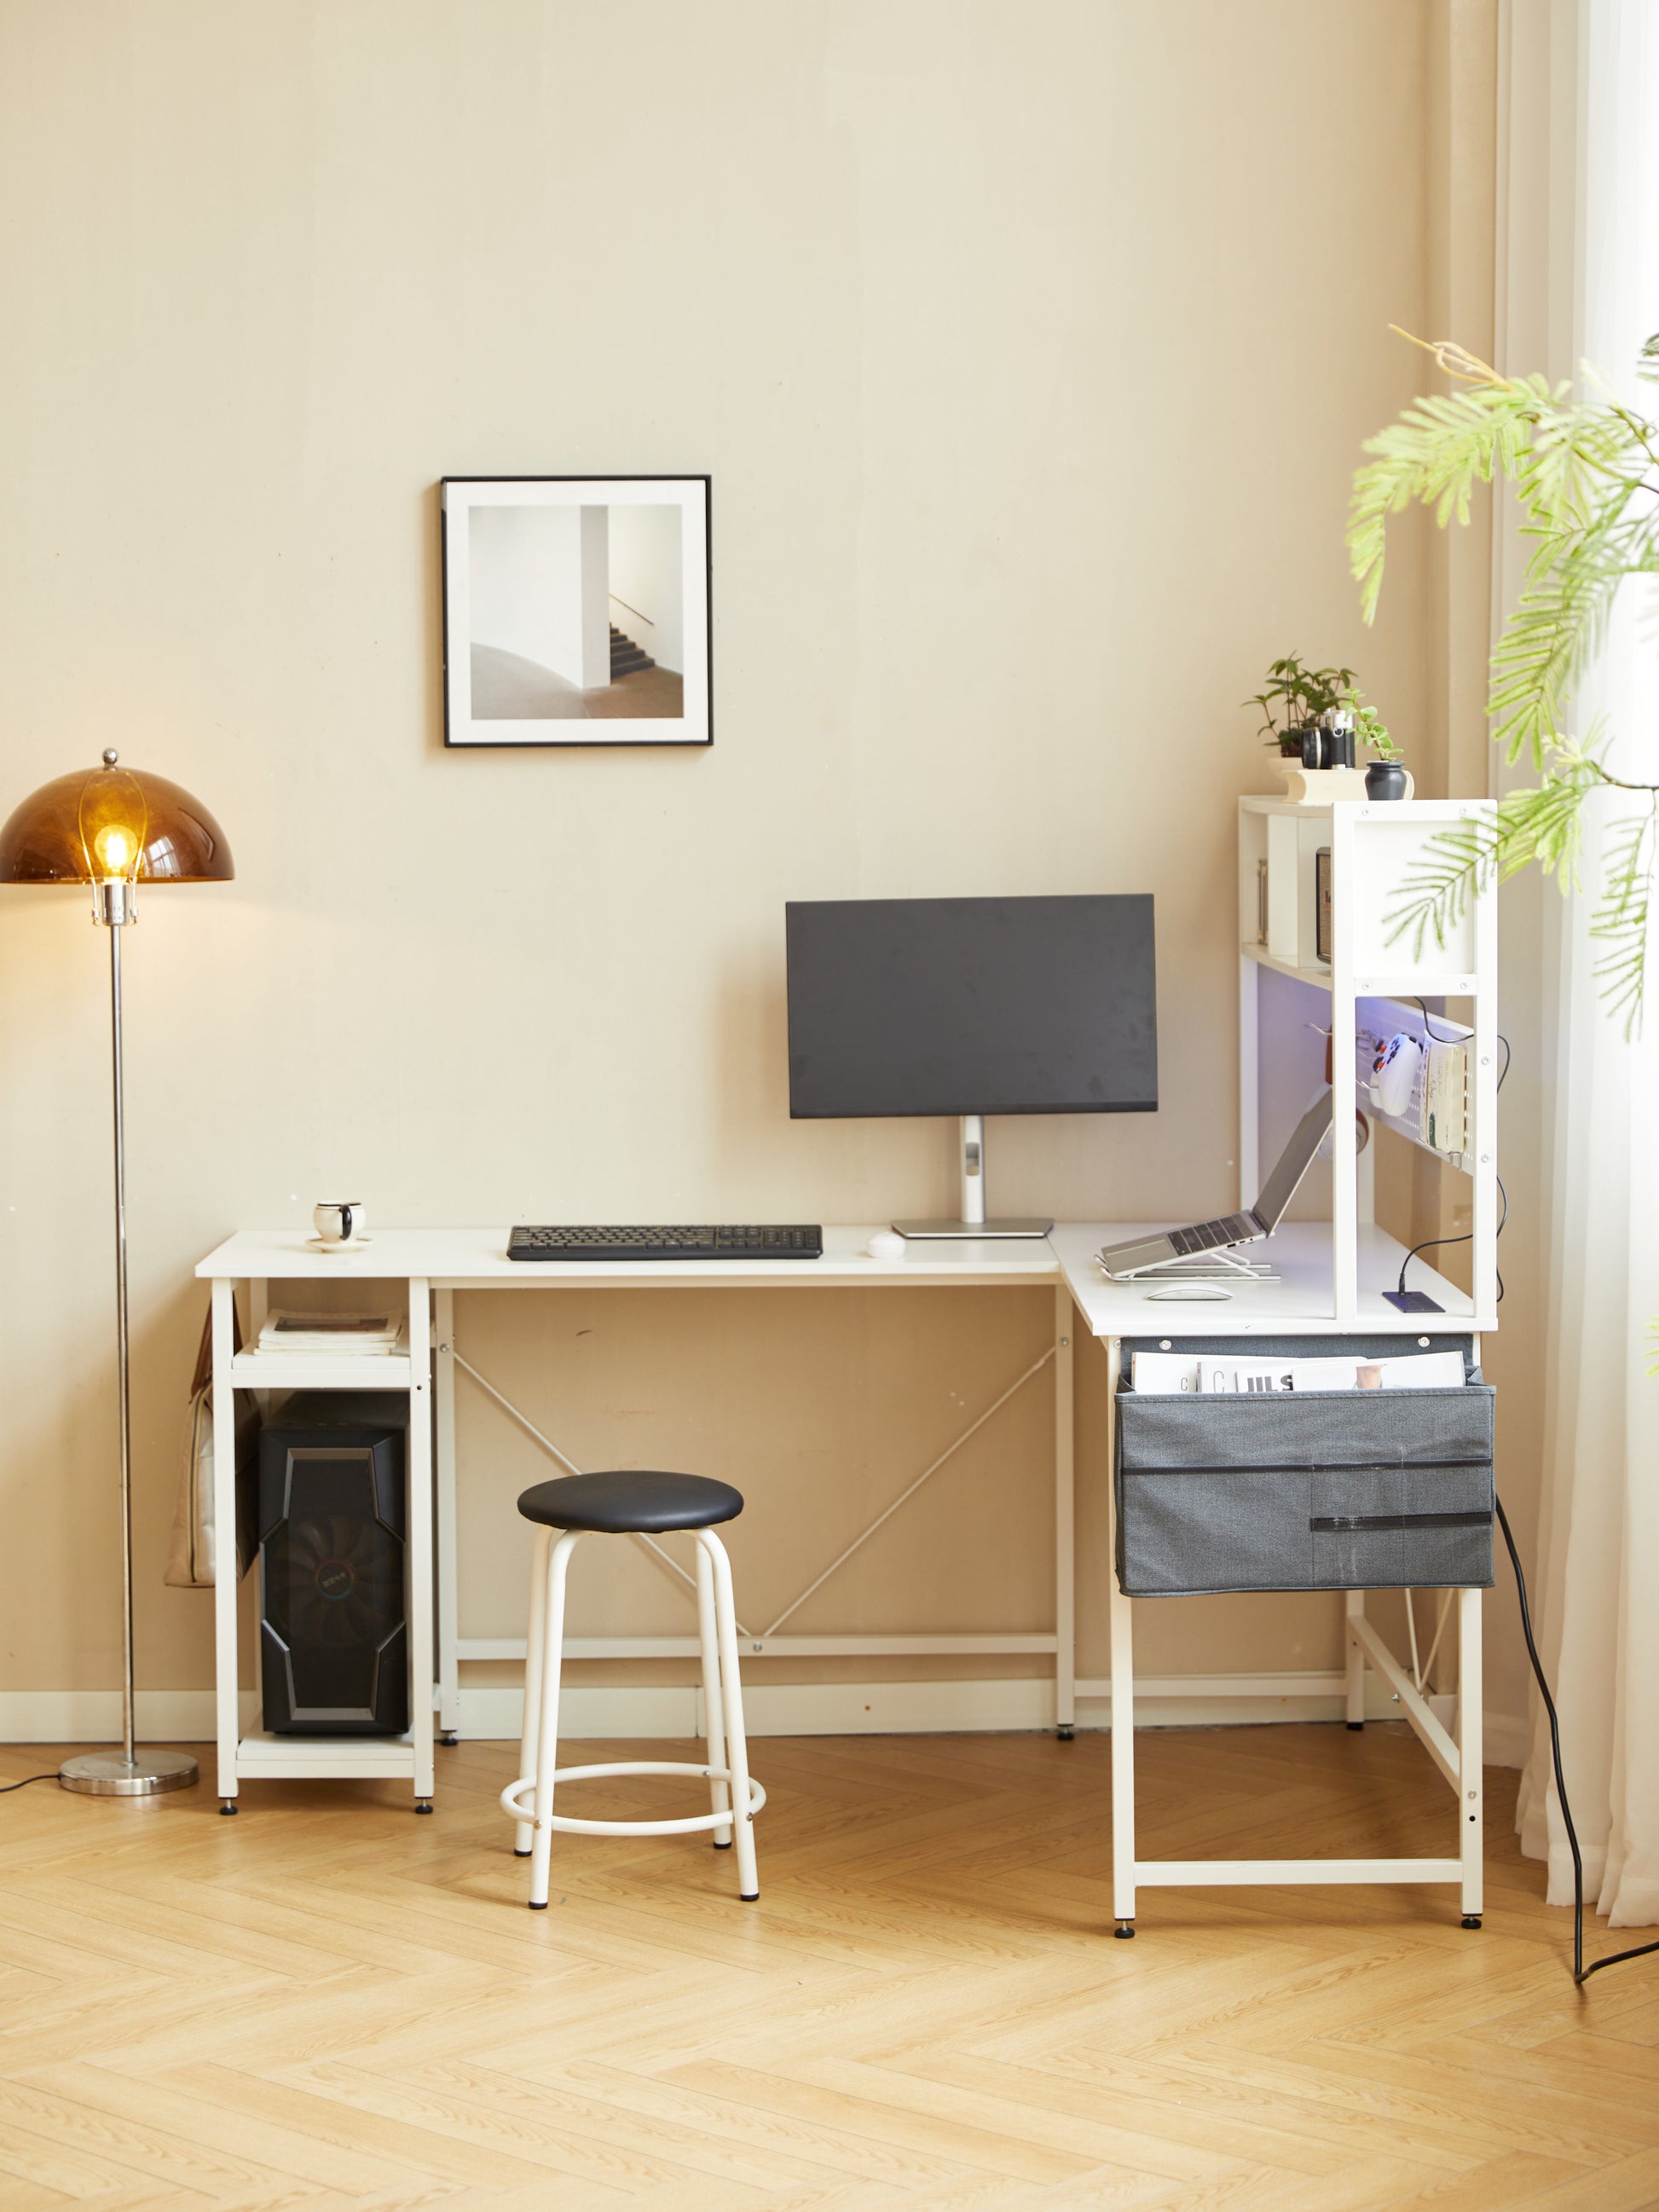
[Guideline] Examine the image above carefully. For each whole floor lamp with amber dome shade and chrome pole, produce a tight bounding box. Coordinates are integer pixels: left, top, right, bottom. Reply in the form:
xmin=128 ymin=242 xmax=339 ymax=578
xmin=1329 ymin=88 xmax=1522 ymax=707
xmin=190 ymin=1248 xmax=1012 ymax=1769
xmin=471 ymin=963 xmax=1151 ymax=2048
xmin=0 ymin=750 xmax=234 ymax=1796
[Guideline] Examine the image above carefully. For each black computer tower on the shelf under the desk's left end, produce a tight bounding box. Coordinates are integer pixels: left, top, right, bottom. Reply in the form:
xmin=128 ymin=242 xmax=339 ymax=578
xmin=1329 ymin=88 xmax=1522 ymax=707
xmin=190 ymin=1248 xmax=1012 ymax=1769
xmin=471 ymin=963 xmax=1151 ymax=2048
xmin=259 ymin=1389 xmax=409 ymax=1736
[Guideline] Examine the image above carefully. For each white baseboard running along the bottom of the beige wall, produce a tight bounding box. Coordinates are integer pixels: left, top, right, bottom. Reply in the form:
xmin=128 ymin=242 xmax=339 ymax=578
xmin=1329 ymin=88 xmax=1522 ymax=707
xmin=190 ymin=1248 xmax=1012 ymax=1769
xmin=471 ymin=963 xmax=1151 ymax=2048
xmin=0 ymin=1670 xmax=1529 ymax=1768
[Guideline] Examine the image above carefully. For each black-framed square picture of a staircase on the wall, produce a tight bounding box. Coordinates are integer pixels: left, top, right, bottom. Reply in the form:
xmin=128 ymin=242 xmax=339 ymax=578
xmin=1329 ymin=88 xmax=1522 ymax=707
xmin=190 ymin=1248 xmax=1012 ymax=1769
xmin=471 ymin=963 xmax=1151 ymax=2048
xmin=442 ymin=476 xmax=714 ymax=745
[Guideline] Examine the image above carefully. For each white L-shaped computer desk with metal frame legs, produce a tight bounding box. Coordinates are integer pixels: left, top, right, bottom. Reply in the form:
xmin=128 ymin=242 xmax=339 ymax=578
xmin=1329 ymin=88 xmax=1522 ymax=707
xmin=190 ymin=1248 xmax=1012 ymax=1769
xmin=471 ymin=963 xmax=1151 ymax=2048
xmin=197 ymin=1223 xmax=1493 ymax=1926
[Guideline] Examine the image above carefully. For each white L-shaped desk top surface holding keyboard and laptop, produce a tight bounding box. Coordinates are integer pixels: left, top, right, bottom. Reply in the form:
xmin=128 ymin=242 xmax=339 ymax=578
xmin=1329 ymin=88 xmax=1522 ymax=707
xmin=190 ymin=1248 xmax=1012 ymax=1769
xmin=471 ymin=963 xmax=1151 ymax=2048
xmin=197 ymin=1221 xmax=1495 ymax=1336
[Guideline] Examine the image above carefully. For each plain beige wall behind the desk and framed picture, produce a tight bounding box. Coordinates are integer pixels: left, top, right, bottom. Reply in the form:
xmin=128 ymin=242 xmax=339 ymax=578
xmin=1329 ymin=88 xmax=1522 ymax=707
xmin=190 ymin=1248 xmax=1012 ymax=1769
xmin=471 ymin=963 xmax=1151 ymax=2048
xmin=0 ymin=0 xmax=1486 ymax=1690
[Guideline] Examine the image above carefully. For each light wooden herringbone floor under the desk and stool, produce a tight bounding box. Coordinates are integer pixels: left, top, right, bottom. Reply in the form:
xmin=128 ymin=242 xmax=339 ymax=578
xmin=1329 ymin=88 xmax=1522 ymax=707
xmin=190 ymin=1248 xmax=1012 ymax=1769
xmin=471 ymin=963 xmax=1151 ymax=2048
xmin=0 ymin=1725 xmax=1659 ymax=2212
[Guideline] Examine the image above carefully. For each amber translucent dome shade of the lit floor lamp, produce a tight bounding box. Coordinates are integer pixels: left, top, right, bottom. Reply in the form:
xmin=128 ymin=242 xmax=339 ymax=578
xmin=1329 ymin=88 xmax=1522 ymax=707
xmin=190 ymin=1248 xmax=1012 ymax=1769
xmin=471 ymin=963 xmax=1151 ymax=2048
xmin=0 ymin=750 xmax=237 ymax=885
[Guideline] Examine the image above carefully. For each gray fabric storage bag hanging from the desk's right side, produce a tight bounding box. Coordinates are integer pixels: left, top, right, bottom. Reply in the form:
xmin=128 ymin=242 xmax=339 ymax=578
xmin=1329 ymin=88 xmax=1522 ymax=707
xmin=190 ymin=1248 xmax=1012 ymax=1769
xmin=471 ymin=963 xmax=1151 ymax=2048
xmin=1115 ymin=1336 xmax=1495 ymax=1597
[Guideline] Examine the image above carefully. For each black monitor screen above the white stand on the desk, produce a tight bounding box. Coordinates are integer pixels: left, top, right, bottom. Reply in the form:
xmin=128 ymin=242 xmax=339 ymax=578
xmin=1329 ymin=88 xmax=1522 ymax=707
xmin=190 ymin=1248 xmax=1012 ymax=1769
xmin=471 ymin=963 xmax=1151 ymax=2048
xmin=785 ymin=894 xmax=1157 ymax=1121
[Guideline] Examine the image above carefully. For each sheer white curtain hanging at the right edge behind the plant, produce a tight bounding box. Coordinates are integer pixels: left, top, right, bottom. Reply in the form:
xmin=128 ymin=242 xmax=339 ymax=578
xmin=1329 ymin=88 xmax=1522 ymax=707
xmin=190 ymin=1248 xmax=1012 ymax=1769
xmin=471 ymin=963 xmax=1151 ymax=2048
xmin=1511 ymin=0 xmax=1659 ymax=1926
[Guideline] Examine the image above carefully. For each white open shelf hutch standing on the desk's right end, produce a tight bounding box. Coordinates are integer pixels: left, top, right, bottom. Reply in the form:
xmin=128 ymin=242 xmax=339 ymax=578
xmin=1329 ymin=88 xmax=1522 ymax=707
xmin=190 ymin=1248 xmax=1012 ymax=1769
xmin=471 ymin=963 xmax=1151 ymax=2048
xmin=1239 ymin=796 xmax=1502 ymax=1329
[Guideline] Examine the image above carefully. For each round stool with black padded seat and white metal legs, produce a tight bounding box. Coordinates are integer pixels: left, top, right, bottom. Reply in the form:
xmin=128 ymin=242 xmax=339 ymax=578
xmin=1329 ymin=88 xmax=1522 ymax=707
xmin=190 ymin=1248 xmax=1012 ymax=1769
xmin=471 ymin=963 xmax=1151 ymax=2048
xmin=502 ymin=1468 xmax=766 ymax=1911
